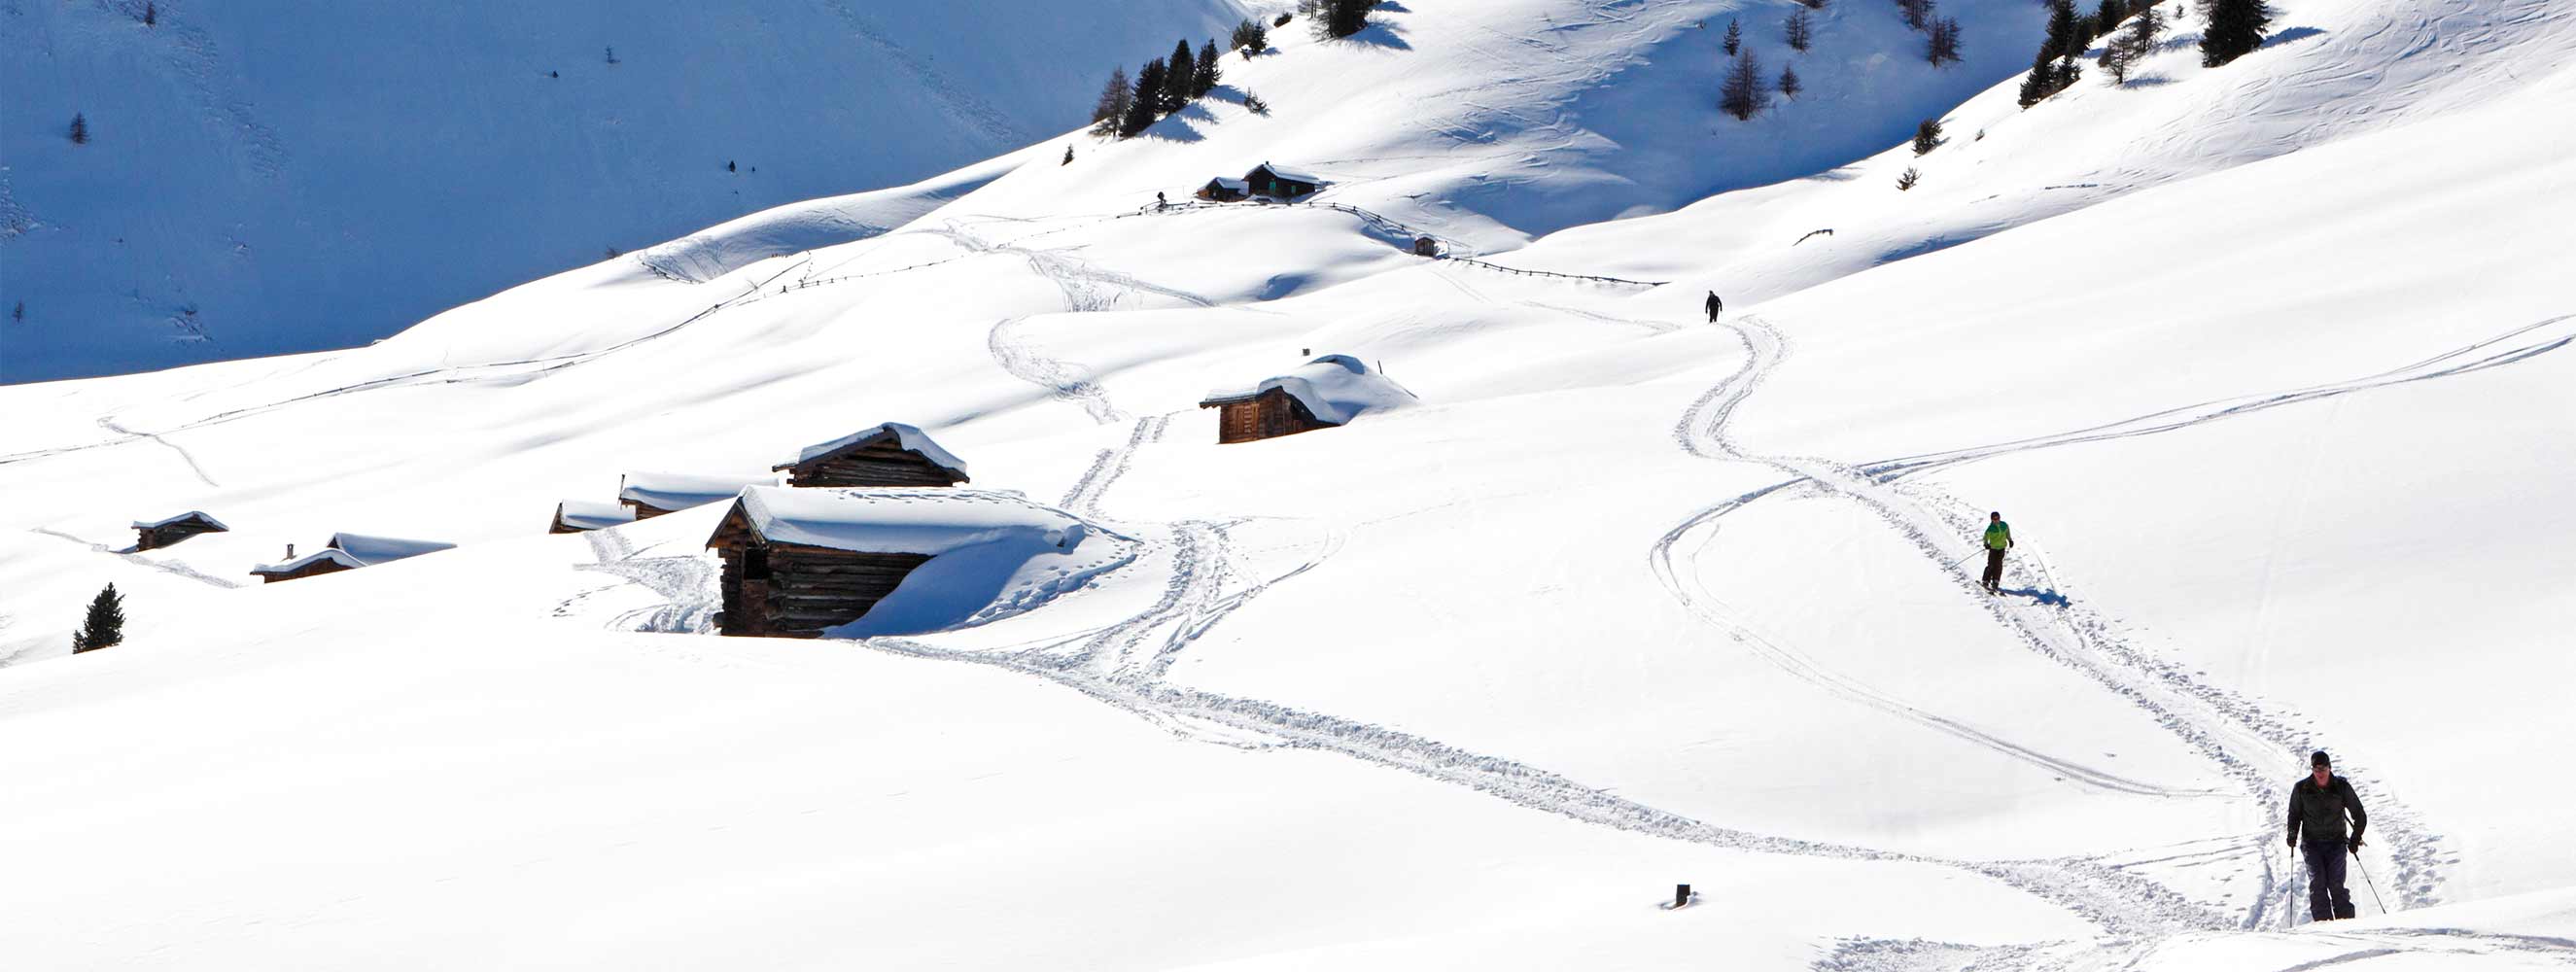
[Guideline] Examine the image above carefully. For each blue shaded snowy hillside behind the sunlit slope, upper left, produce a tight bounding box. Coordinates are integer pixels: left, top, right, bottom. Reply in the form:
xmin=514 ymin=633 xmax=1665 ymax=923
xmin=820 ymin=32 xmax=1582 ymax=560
xmin=0 ymin=0 xmax=1241 ymax=382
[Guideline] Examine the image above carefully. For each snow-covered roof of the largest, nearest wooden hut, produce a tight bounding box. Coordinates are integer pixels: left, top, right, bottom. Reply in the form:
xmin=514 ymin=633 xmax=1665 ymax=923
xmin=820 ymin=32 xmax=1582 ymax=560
xmin=740 ymin=487 xmax=1085 ymax=557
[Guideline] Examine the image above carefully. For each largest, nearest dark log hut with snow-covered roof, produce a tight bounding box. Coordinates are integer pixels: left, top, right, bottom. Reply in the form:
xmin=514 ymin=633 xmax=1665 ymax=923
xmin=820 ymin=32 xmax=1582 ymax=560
xmin=706 ymin=487 xmax=1085 ymax=637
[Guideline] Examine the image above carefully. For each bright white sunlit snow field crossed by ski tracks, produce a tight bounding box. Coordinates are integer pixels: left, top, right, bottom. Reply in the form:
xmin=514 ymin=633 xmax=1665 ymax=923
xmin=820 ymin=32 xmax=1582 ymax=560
xmin=0 ymin=0 xmax=2576 ymax=972
